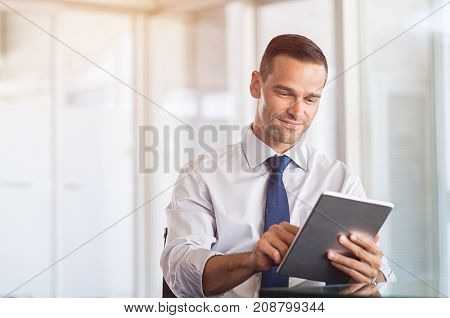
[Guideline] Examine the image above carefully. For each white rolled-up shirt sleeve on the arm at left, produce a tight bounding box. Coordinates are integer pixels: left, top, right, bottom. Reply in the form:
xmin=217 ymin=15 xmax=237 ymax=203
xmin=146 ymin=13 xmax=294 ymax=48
xmin=161 ymin=164 xmax=221 ymax=297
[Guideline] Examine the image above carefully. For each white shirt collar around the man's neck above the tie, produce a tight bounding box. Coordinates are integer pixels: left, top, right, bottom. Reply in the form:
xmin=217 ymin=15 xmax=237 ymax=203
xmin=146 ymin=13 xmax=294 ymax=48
xmin=242 ymin=124 xmax=308 ymax=171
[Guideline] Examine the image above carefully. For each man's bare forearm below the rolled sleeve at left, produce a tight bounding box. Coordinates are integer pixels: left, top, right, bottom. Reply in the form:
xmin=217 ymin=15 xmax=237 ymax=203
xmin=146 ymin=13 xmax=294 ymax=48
xmin=202 ymin=252 xmax=256 ymax=297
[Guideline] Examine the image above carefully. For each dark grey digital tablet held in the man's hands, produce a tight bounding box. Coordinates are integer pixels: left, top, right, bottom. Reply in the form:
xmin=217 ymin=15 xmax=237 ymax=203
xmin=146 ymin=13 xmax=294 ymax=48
xmin=277 ymin=191 xmax=394 ymax=284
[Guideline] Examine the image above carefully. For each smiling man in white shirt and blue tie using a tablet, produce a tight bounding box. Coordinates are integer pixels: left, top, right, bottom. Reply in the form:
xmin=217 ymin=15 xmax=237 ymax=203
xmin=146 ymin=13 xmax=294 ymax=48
xmin=161 ymin=34 xmax=395 ymax=297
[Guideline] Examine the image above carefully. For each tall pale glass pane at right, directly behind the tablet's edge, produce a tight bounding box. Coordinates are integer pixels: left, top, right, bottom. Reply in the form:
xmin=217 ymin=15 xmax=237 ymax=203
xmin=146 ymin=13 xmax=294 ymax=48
xmin=362 ymin=0 xmax=438 ymax=281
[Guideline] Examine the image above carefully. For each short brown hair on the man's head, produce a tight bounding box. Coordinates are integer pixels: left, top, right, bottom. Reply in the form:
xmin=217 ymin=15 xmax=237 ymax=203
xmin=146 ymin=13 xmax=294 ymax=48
xmin=259 ymin=34 xmax=328 ymax=81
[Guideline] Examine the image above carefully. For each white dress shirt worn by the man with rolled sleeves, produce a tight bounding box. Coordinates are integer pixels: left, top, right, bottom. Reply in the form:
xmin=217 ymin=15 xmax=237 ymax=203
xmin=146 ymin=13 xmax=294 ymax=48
xmin=161 ymin=127 xmax=396 ymax=297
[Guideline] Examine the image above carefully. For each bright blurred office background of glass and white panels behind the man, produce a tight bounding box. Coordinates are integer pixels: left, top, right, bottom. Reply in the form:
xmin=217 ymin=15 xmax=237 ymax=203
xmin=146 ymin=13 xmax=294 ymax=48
xmin=0 ymin=0 xmax=450 ymax=297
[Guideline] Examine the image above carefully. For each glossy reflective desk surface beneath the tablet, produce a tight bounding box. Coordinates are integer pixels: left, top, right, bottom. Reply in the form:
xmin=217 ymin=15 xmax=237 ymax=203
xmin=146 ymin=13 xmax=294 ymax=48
xmin=260 ymin=281 xmax=448 ymax=298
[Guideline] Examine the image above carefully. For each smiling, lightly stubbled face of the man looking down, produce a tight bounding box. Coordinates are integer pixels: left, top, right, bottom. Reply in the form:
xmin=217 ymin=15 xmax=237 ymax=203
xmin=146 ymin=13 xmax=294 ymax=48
xmin=250 ymin=55 xmax=327 ymax=152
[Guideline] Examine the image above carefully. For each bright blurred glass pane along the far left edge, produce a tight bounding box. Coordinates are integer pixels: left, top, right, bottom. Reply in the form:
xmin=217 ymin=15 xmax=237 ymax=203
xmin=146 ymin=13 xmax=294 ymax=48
xmin=0 ymin=11 xmax=55 ymax=297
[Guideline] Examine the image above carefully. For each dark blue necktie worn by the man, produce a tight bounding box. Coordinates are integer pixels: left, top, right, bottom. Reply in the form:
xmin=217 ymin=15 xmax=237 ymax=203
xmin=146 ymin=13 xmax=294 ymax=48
xmin=261 ymin=156 xmax=291 ymax=287
